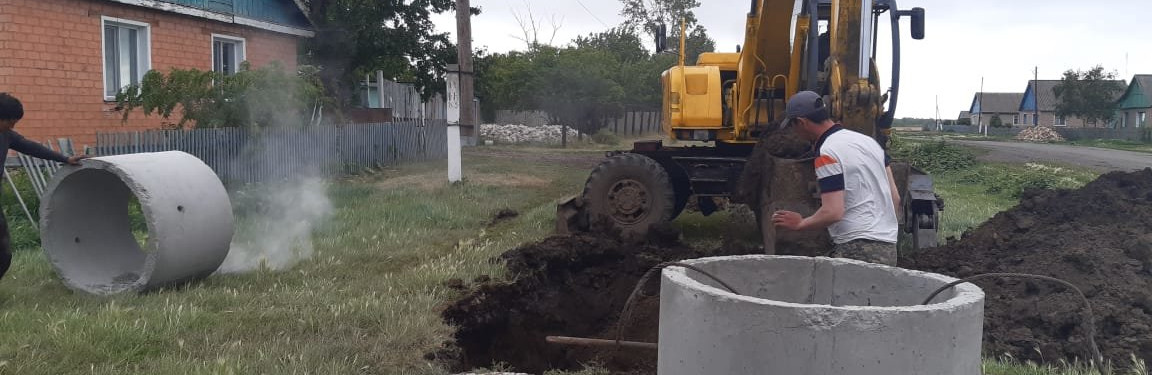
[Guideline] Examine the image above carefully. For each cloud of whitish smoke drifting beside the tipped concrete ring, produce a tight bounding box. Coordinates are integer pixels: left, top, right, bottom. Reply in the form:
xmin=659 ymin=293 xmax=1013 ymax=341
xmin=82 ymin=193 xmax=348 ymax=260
xmin=218 ymin=131 xmax=332 ymax=274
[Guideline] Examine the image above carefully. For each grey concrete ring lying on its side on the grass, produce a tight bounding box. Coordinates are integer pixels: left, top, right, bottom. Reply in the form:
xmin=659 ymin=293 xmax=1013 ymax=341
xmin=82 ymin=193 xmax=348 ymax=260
xmin=40 ymin=151 xmax=234 ymax=294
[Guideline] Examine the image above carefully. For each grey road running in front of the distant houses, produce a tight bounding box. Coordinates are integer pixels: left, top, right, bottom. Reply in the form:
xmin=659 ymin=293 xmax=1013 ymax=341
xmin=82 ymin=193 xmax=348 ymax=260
xmin=955 ymin=140 xmax=1152 ymax=171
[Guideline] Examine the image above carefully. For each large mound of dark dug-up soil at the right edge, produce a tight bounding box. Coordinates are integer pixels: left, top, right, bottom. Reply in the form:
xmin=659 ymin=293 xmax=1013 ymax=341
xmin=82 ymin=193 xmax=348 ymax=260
xmin=900 ymin=169 xmax=1152 ymax=365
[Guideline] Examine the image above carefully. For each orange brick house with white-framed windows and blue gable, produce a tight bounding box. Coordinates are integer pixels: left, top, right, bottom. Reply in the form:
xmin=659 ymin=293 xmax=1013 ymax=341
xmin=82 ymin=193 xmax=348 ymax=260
xmin=0 ymin=0 xmax=313 ymax=148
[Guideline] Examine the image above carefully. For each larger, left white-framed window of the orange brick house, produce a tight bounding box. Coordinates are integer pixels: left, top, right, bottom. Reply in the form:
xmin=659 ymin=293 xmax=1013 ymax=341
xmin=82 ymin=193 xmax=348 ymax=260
xmin=100 ymin=17 xmax=152 ymax=100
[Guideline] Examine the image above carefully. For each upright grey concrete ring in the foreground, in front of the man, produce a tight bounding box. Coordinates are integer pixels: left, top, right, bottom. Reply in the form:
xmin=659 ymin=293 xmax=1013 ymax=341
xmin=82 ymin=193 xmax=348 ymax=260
xmin=658 ymin=255 xmax=984 ymax=375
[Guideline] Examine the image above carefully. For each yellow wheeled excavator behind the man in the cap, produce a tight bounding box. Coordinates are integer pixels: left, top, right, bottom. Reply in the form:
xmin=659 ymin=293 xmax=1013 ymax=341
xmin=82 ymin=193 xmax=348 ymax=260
xmin=556 ymin=0 xmax=942 ymax=253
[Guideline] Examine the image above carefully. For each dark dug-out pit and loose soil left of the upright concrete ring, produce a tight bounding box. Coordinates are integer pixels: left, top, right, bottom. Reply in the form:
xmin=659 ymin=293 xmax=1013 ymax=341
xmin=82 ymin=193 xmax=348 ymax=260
xmin=430 ymin=225 xmax=756 ymax=374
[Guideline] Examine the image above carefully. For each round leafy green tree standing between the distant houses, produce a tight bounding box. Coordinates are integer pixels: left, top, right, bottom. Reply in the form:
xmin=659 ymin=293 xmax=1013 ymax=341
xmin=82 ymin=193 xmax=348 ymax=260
xmin=1053 ymin=66 xmax=1126 ymax=127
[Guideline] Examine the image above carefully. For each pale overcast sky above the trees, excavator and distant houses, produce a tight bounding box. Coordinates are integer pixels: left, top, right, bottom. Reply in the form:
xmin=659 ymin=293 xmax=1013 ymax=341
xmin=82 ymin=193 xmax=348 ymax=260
xmin=434 ymin=0 xmax=1152 ymax=118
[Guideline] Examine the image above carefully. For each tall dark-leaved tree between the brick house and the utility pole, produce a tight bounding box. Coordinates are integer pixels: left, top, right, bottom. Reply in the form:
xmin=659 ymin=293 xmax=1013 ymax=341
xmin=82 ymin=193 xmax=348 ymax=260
xmin=301 ymin=0 xmax=479 ymax=108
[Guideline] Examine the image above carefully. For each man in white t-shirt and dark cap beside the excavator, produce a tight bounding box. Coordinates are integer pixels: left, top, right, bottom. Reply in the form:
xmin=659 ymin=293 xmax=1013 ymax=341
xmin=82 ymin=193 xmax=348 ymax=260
xmin=772 ymin=91 xmax=900 ymax=266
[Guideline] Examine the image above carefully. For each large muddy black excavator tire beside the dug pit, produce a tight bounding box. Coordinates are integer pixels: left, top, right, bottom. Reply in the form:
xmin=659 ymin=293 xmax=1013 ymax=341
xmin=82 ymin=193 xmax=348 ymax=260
xmin=583 ymin=153 xmax=676 ymax=238
